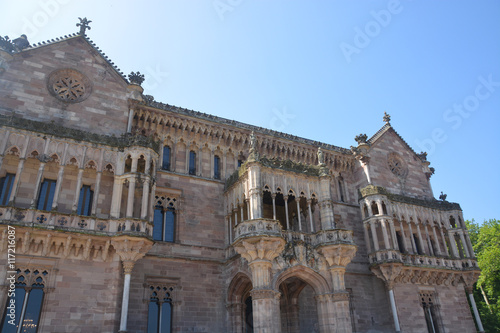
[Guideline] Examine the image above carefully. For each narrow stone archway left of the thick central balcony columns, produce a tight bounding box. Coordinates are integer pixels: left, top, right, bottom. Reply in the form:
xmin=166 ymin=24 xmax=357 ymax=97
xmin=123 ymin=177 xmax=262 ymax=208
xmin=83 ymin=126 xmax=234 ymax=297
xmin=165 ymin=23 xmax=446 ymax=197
xmin=227 ymin=272 xmax=253 ymax=333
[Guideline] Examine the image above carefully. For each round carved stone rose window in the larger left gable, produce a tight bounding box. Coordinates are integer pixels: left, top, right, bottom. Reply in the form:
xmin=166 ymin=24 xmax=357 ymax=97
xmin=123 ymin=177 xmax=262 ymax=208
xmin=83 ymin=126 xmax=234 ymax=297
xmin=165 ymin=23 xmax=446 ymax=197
xmin=47 ymin=69 xmax=92 ymax=103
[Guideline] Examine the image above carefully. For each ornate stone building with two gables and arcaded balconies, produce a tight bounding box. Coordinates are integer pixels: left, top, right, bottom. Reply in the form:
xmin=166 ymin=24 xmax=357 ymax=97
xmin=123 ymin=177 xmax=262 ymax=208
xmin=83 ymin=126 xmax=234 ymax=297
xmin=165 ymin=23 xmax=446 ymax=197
xmin=0 ymin=20 xmax=482 ymax=333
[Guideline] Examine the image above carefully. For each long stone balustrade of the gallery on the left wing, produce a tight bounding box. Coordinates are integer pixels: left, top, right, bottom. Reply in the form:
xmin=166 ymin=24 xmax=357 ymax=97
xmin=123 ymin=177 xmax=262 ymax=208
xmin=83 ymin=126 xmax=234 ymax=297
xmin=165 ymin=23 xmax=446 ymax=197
xmin=0 ymin=207 xmax=153 ymax=237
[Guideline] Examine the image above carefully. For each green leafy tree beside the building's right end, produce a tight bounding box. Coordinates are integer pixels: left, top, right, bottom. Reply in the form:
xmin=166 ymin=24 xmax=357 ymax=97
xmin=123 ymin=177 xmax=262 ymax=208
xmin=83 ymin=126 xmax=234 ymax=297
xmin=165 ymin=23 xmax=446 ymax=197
xmin=466 ymin=219 xmax=500 ymax=333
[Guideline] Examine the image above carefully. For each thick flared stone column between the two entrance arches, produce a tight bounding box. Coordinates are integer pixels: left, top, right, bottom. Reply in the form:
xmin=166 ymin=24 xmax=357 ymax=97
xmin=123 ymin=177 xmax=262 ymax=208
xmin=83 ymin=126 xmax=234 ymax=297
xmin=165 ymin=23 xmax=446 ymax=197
xmin=234 ymin=234 xmax=285 ymax=333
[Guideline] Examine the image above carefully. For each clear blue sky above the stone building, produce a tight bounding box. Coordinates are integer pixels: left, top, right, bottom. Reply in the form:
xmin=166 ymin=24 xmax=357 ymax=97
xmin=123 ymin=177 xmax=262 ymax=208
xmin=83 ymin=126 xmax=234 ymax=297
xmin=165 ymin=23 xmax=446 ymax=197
xmin=0 ymin=0 xmax=500 ymax=222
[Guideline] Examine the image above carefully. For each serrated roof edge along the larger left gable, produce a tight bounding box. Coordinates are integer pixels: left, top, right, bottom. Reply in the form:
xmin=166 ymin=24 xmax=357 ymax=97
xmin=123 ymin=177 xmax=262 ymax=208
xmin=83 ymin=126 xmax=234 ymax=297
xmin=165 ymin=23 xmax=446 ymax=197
xmin=0 ymin=33 xmax=129 ymax=84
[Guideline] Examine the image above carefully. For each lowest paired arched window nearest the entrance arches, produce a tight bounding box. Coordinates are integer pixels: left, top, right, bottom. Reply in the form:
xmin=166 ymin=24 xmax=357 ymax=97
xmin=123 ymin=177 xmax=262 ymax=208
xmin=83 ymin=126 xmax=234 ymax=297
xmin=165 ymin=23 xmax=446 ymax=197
xmin=147 ymin=286 xmax=173 ymax=333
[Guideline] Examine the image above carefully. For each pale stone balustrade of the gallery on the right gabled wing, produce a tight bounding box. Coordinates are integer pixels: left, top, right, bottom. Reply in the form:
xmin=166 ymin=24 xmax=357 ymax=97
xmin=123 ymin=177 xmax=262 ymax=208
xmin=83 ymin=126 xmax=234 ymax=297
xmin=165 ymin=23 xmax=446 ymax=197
xmin=368 ymin=250 xmax=479 ymax=270
